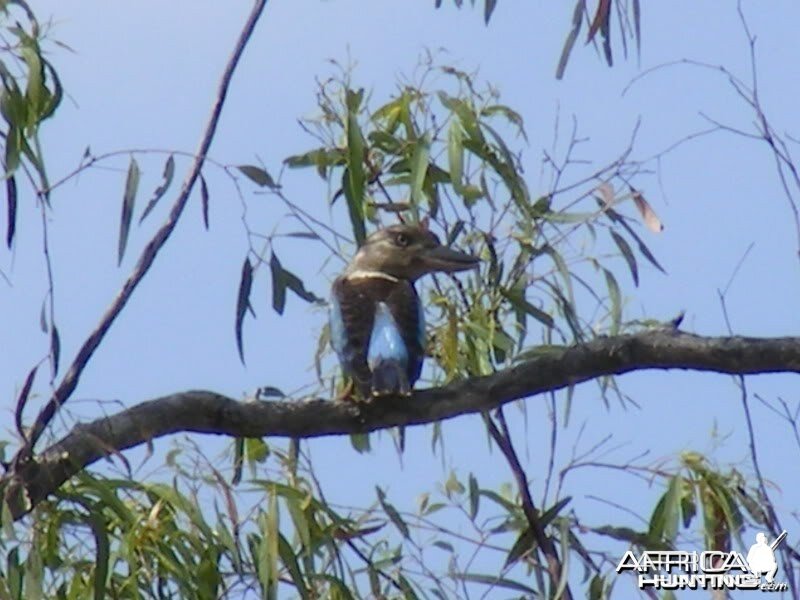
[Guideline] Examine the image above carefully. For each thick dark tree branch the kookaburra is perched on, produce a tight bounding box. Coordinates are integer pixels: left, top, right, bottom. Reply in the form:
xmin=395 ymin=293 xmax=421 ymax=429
xmin=0 ymin=329 xmax=800 ymax=518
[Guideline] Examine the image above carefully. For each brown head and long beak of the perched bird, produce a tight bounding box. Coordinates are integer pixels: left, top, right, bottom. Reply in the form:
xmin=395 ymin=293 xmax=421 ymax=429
xmin=347 ymin=225 xmax=480 ymax=281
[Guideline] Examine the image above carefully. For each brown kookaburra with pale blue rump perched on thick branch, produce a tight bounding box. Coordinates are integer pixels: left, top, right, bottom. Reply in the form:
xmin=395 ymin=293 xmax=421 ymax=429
xmin=330 ymin=221 xmax=480 ymax=399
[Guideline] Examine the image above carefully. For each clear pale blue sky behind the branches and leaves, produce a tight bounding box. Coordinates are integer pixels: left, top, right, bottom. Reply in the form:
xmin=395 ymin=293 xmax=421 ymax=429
xmin=0 ymin=0 xmax=800 ymax=596
